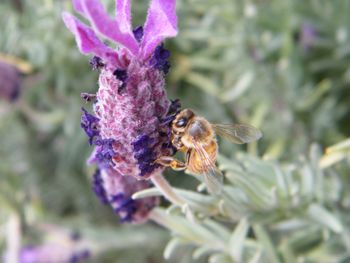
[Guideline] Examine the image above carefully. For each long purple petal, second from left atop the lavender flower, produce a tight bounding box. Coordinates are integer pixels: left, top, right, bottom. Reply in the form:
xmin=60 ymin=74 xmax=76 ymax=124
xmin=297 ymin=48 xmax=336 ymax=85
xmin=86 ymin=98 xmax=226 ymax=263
xmin=77 ymin=0 xmax=138 ymax=55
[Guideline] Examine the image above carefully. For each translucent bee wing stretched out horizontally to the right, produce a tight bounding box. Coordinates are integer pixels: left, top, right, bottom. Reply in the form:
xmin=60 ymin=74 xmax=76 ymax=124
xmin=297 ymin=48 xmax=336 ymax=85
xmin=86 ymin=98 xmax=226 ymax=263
xmin=212 ymin=124 xmax=262 ymax=144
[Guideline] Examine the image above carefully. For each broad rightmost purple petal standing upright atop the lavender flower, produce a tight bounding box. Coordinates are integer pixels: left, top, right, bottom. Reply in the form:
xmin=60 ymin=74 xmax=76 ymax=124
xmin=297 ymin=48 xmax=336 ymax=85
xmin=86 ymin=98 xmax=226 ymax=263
xmin=141 ymin=0 xmax=177 ymax=58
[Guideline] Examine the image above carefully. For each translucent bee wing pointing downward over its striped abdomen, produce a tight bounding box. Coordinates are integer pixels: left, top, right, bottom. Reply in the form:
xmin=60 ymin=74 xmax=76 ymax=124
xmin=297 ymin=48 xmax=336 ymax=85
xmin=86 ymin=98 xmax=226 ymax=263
xmin=192 ymin=140 xmax=223 ymax=195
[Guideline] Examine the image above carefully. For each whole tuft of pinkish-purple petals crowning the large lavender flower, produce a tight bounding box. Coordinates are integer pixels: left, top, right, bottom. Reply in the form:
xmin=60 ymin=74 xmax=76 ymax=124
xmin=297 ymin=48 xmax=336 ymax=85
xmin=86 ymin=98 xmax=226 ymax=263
xmin=63 ymin=0 xmax=177 ymax=65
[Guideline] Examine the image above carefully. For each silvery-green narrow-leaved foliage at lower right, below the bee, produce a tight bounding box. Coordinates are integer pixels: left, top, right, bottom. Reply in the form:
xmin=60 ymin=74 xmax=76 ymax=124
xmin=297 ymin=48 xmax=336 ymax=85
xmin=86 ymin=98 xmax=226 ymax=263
xmin=134 ymin=142 xmax=350 ymax=262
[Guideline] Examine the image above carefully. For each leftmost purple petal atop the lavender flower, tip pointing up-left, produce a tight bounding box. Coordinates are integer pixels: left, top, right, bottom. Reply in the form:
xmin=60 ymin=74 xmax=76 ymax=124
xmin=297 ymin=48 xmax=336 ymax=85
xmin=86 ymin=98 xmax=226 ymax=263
xmin=62 ymin=12 xmax=119 ymax=65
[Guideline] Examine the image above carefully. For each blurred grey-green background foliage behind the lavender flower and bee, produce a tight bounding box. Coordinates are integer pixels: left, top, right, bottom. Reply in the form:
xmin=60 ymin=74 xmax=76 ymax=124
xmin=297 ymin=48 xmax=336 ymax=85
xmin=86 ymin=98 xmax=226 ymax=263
xmin=0 ymin=0 xmax=350 ymax=263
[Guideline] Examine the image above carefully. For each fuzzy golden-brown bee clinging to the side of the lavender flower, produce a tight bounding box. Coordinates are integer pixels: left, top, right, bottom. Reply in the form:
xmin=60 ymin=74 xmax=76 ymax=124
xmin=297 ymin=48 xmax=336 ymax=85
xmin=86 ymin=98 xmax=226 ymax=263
xmin=155 ymin=109 xmax=262 ymax=194
